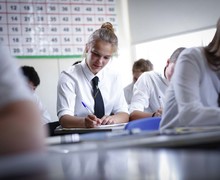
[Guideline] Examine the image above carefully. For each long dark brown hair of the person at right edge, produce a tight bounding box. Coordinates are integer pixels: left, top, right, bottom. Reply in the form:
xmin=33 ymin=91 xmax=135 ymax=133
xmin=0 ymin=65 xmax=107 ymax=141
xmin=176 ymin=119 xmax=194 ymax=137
xmin=204 ymin=19 xmax=220 ymax=71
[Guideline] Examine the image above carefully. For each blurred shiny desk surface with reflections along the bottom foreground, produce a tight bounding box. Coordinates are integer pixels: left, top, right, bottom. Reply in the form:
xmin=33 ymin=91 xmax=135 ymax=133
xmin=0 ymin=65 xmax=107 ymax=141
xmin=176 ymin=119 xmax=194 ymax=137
xmin=0 ymin=147 xmax=220 ymax=180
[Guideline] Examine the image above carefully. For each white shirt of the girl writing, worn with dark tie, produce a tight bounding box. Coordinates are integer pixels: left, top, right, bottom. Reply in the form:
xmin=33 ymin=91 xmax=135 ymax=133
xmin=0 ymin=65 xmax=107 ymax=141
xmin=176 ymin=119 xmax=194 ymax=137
xmin=57 ymin=60 xmax=128 ymax=118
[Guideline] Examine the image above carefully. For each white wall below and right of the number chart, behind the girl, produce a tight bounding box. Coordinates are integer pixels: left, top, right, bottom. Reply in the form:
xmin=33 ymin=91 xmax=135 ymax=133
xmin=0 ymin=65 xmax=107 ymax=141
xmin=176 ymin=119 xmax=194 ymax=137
xmin=19 ymin=0 xmax=132 ymax=121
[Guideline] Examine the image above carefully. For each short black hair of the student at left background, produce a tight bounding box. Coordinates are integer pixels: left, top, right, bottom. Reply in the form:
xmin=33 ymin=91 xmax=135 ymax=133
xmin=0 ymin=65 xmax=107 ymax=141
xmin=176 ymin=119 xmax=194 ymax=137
xmin=21 ymin=66 xmax=40 ymax=87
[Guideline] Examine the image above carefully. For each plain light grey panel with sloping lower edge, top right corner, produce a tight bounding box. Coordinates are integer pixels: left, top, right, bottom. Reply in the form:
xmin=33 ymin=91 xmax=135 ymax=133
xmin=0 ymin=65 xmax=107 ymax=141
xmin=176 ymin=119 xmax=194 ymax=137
xmin=128 ymin=0 xmax=220 ymax=44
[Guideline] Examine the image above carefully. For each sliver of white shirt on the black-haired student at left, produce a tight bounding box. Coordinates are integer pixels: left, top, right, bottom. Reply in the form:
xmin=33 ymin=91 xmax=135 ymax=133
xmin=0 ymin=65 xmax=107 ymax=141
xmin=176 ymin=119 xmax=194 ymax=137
xmin=33 ymin=92 xmax=52 ymax=125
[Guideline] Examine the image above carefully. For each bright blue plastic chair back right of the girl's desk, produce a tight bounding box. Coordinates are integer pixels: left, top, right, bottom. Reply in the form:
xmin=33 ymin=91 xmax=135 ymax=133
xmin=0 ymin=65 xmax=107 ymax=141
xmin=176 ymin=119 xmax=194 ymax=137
xmin=125 ymin=117 xmax=161 ymax=131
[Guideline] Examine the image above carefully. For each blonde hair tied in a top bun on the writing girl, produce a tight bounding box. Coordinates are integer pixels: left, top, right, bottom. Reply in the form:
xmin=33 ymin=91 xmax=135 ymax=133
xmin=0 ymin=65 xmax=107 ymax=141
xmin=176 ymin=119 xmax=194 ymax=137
xmin=87 ymin=22 xmax=118 ymax=53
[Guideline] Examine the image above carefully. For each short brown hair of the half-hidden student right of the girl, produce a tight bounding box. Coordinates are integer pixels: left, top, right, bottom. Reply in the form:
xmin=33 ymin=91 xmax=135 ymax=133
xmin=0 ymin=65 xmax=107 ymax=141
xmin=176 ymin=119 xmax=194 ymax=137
xmin=132 ymin=59 xmax=153 ymax=72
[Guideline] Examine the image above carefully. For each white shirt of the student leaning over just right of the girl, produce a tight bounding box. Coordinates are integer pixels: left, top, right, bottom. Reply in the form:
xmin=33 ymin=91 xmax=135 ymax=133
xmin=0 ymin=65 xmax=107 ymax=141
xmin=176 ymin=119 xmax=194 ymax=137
xmin=129 ymin=71 xmax=168 ymax=113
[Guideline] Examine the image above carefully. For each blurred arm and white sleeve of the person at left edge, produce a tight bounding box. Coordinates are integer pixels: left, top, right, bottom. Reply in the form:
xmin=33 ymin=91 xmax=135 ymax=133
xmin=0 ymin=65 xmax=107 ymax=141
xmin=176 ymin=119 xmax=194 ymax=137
xmin=0 ymin=45 xmax=46 ymax=156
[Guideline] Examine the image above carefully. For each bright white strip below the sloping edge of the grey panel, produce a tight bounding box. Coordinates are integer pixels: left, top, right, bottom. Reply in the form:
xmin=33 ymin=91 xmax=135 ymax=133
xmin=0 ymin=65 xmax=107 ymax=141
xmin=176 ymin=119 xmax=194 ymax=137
xmin=134 ymin=28 xmax=215 ymax=73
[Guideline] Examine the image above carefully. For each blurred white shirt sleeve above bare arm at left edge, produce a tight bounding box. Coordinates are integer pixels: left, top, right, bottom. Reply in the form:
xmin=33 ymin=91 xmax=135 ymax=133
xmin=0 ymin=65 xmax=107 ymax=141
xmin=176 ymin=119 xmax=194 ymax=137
xmin=0 ymin=44 xmax=32 ymax=107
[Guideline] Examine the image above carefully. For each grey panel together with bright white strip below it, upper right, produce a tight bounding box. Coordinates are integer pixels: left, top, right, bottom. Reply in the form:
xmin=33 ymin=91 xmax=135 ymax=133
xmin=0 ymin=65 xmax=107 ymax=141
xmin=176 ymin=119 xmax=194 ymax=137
xmin=128 ymin=0 xmax=220 ymax=83
